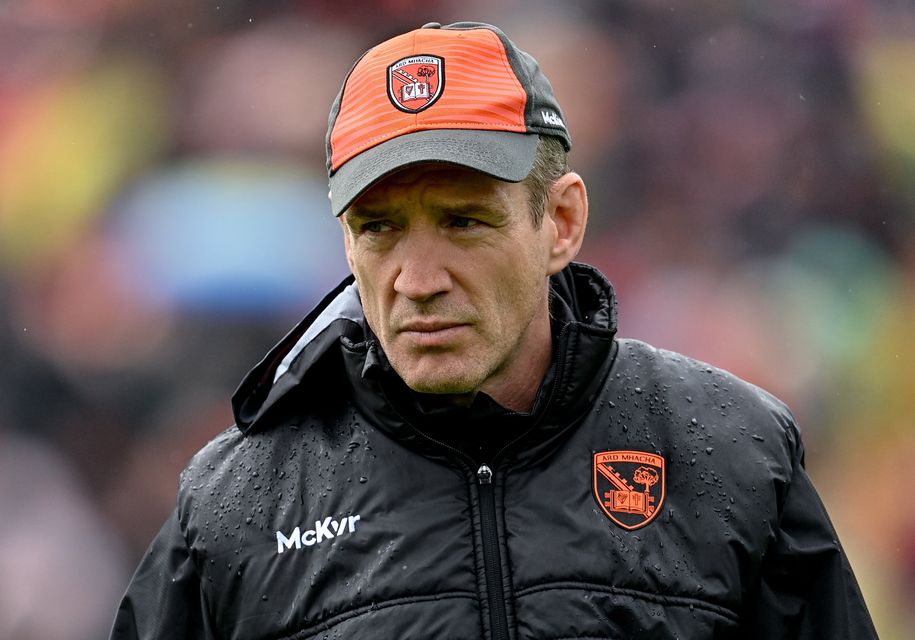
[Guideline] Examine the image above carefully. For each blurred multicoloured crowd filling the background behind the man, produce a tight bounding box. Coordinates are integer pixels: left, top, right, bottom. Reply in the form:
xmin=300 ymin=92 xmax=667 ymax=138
xmin=0 ymin=0 xmax=915 ymax=640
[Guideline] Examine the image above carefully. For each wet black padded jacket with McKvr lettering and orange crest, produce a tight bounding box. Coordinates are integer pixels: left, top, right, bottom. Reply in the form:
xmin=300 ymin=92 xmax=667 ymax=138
xmin=112 ymin=265 xmax=876 ymax=640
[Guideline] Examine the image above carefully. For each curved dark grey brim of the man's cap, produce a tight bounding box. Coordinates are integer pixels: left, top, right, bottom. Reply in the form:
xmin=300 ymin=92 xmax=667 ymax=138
xmin=330 ymin=129 xmax=539 ymax=216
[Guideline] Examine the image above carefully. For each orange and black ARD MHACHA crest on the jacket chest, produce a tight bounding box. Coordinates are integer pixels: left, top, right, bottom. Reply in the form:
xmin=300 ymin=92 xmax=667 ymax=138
xmin=592 ymin=451 xmax=665 ymax=531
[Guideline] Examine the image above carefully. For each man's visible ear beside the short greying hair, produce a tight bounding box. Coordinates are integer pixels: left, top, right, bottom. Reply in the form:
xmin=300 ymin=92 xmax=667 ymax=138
xmin=543 ymin=171 xmax=588 ymax=275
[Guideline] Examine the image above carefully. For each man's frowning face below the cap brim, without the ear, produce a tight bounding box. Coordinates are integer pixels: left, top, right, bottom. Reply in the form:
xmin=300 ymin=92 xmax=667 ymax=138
xmin=342 ymin=164 xmax=555 ymax=396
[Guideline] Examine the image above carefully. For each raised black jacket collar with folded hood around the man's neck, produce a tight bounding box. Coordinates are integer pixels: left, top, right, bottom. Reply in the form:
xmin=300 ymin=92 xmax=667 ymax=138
xmin=232 ymin=263 xmax=617 ymax=452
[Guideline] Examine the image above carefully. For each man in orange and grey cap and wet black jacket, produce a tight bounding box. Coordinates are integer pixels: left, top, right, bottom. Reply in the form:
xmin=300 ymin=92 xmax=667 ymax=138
xmin=112 ymin=23 xmax=876 ymax=640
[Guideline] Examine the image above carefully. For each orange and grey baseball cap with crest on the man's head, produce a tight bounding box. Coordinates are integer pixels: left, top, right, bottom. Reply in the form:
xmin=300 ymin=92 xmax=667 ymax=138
xmin=327 ymin=22 xmax=572 ymax=216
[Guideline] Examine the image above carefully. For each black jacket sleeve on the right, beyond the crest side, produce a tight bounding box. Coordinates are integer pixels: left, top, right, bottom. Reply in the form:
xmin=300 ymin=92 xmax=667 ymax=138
xmin=739 ymin=431 xmax=877 ymax=640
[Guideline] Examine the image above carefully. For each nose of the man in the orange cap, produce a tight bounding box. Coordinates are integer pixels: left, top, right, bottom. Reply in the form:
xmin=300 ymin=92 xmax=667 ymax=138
xmin=394 ymin=229 xmax=452 ymax=302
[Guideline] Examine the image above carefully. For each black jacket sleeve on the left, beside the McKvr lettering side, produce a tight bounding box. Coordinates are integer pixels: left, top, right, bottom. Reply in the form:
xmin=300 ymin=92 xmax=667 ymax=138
xmin=110 ymin=509 xmax=215 ymax=640
